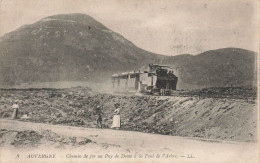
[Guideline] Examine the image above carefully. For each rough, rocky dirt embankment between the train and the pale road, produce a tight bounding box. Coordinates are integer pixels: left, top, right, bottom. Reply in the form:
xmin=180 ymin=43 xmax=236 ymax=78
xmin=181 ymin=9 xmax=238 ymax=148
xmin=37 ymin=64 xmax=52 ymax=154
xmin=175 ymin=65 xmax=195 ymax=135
xmin=0 ymin=88 xmax=257 ymax=141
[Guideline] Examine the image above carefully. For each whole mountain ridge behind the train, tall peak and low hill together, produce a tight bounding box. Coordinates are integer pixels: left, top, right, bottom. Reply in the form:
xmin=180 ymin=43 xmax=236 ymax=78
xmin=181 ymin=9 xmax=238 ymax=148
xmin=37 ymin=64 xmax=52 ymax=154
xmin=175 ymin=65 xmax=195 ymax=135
xmin=0 ymin=14 xmax=256 ymax=89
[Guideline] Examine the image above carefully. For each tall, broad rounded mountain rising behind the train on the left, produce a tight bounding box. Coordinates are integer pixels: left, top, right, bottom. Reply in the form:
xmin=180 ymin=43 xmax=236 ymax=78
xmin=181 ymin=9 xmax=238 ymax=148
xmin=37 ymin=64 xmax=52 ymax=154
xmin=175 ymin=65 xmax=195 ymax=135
xmin=0 ymin=14 xmax=161 ymax=85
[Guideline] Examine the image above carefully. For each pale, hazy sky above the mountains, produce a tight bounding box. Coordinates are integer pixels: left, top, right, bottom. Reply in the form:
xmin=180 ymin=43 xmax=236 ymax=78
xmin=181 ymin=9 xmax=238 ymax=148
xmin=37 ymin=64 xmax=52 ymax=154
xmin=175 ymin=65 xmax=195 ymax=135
xmin=0 ymin=0 xmax=259 ymax=56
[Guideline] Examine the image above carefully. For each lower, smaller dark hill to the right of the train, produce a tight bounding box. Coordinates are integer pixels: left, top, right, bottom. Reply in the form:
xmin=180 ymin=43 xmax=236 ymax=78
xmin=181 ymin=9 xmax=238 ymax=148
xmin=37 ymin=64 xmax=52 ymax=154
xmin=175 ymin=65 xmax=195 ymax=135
xmin=163 ymin=48 xmax=257 ymax=89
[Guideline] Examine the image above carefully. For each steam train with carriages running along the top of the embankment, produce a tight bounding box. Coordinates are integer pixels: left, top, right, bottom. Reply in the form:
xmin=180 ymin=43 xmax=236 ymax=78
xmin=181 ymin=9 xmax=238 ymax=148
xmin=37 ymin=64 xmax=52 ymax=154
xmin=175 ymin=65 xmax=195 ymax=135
xmin=111 ymin=64 xmax=178 ymax=96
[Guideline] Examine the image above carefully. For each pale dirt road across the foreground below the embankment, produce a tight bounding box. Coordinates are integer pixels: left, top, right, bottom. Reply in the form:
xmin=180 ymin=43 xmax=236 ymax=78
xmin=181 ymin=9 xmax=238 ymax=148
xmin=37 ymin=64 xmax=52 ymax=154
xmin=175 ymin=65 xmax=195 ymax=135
xmin=0 ymin=119 xmax=257 ymax=162
